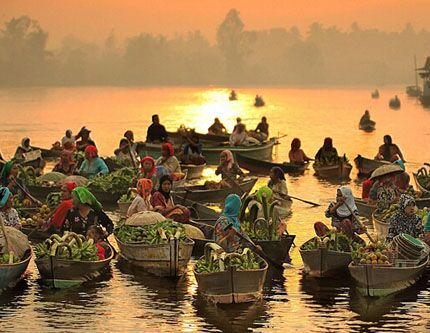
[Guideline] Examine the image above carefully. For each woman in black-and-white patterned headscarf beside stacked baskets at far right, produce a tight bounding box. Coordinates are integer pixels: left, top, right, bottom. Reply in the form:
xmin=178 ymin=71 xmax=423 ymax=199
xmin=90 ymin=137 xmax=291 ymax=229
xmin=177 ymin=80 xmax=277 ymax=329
xmin=385 ymin=194 xmax=424 ymax=242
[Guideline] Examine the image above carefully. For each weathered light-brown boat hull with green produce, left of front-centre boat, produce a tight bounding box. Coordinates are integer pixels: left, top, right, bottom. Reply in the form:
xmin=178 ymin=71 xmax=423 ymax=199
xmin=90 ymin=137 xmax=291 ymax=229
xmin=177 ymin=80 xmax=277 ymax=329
xmin=115 ymin=237 xmax=194 ymax=277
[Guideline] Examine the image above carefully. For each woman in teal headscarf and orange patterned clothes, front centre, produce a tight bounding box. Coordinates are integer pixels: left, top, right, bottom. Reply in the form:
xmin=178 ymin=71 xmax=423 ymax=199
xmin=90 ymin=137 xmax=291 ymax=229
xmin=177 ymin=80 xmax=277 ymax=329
xmin=214 ymin=194 xmax=242 ymax=252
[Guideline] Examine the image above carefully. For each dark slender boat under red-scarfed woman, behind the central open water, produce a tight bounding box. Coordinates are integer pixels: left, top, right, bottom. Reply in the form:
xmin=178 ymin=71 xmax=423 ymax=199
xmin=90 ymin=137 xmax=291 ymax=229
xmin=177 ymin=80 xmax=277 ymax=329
xmin=236 ymin=154 xmax=309 ymax=175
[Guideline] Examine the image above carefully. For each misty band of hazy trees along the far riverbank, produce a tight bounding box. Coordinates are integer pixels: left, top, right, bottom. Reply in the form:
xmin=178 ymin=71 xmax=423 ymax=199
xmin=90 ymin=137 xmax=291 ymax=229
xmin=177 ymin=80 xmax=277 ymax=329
xmin=0 ymin=9 xmax=430 ymax=88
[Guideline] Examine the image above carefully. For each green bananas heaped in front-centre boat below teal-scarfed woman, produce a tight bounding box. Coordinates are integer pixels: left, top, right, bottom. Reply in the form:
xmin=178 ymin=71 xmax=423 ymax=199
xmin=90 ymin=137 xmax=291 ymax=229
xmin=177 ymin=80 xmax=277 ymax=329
xmin=194 ymin=243 xmax=260 ymax=274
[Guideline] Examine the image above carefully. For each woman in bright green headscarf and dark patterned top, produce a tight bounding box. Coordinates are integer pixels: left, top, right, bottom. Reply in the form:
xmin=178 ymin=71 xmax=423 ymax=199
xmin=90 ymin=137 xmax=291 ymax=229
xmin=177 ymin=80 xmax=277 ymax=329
xmin=61 ymin=187 xmax=113 ymax=235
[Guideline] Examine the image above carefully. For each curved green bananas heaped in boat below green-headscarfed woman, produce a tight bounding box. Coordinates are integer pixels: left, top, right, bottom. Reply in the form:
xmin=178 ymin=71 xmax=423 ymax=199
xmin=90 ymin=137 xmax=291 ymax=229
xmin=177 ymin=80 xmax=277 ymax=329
xmin=34 ymin=232 xmax=99 ymax=261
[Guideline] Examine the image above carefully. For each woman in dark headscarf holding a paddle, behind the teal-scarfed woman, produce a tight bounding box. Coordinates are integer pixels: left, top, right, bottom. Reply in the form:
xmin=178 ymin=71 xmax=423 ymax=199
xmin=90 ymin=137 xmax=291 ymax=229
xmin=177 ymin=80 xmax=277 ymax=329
xmin=267 ymin=167 xmax=291 ymax=219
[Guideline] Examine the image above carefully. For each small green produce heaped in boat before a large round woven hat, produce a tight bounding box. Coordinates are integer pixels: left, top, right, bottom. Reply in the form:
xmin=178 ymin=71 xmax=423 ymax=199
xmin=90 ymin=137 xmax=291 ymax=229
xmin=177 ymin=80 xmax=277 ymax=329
xmin=114 ymin=220 xmax=186 ymax=245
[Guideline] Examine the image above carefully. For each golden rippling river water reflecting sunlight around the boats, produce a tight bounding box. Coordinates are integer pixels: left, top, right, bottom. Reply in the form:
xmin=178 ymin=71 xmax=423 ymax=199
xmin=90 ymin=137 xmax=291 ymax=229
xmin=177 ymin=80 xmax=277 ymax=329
xmin=0 ymin=87 xmax=430 ymax=332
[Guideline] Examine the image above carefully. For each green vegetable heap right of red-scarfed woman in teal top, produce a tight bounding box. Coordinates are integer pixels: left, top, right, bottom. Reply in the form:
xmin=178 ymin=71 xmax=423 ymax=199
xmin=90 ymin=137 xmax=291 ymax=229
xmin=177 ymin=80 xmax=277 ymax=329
xmin=87 ymin=168 xmax=138 ymax=194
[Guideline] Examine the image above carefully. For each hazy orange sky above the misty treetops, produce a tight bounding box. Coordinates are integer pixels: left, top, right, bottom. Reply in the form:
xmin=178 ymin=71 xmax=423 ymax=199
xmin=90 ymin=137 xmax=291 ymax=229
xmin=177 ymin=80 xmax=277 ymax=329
xmin=0 ymin=0 xmax=430 ymax=46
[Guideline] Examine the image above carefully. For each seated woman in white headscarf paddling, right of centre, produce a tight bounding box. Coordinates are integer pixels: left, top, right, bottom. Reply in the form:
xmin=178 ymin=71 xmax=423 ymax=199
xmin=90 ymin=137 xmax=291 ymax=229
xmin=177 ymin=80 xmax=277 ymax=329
xmin=325 ymin=186 xmax=365 ymax=235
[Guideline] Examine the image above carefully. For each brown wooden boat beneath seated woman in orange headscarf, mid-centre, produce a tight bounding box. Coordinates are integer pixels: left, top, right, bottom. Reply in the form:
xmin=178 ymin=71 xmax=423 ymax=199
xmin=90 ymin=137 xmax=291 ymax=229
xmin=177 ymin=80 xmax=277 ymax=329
xmin=173 ymin=177 xmax=258 ymax=203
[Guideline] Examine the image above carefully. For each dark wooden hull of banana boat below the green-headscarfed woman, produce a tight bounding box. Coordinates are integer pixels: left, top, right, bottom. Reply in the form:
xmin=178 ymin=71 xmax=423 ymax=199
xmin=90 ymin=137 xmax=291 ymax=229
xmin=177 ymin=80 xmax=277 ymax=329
xmin=35 ymin=246 xmax=114 ymax=288
